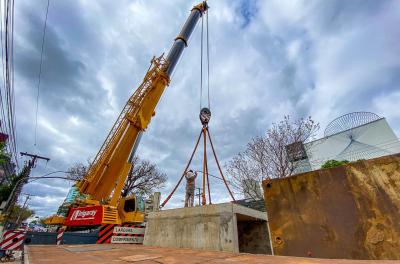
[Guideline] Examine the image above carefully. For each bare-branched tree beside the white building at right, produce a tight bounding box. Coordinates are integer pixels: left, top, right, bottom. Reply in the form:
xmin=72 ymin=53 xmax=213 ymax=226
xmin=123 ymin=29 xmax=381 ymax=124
xmin=226 ymin=116 xmax=319 ymax=199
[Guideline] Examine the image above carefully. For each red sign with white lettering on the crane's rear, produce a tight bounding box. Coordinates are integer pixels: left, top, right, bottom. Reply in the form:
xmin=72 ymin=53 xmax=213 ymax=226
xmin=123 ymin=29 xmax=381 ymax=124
xmin=65 ymin=205 xmax=103 ymax=226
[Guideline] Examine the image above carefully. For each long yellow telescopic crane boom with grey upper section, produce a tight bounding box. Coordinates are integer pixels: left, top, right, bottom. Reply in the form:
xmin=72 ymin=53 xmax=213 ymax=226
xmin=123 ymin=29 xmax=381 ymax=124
xmin=77 ymin=2 xmax=208 ymax=206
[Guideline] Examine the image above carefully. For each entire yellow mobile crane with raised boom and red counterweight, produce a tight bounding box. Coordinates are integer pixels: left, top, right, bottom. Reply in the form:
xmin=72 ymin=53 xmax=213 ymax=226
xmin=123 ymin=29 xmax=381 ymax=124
xmin=46 ymin=2 xmax=208 ymax=226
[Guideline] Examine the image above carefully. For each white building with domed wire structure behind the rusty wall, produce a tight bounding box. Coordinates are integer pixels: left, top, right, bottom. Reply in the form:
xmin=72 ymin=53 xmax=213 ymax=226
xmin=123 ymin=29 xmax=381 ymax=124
xmin=294 ymin=112 xmax=400 ymax=173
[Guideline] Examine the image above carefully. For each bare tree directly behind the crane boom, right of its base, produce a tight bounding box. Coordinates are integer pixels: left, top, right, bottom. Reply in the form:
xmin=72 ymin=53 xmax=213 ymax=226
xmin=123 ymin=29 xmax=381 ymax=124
xmin=122 ymin=157 xmax=167 ymax=197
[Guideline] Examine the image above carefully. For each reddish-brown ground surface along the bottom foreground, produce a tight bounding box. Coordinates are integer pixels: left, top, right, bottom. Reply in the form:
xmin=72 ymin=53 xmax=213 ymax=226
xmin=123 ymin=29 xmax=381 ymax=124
xmin=25 ymin=244 xmax=400 ymax=264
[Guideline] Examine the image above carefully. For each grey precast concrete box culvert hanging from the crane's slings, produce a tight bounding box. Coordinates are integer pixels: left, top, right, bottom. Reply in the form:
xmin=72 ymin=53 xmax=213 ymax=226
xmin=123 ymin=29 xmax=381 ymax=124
xmin=143 ymin=203 xmax=271 ymax=254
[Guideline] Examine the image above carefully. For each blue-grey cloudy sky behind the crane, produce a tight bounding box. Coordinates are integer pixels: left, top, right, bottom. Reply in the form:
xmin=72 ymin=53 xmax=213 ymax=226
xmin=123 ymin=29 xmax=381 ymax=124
xmin=9 ymin=0 xmax=400 ymax=216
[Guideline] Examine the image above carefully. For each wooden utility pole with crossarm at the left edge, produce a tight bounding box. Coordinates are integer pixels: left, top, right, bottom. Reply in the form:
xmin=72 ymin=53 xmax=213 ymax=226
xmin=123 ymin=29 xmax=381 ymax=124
xmin=4 ymin=152 xmax=50 ymax=221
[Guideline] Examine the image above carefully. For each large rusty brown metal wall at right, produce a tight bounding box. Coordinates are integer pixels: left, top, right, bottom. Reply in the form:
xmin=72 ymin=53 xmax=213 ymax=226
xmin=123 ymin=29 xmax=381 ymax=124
xmin=263 ymin=154 xmax=400 ymax=259
